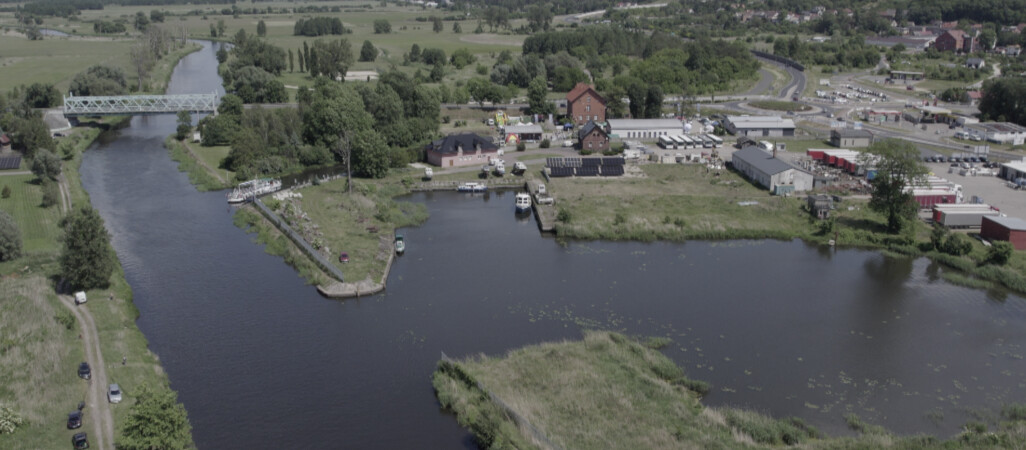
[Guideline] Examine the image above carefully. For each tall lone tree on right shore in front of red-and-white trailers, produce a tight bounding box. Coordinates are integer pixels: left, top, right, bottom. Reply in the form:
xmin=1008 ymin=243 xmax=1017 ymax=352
xmin=867 ymin=139 xmax=926 ymax=234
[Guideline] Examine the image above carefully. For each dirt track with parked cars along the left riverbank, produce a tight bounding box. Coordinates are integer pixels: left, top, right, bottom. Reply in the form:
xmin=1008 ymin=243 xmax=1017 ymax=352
xmin=61 ymin=295 xmax=114 ymax=449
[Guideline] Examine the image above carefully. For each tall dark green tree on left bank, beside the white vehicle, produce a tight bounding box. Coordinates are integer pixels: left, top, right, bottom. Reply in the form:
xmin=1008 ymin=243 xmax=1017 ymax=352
xmin=61 ymin=206 xmax=115 ymax=289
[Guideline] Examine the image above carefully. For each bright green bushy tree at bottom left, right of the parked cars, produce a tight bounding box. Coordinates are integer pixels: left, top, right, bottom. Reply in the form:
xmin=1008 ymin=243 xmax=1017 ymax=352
xmin=116 ymin=385 xmax=192 ymax=450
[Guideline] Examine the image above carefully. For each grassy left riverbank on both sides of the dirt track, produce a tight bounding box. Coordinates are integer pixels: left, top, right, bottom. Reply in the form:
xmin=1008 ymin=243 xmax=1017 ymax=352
xmin=0 ymin=122 xmax=191 ymax=449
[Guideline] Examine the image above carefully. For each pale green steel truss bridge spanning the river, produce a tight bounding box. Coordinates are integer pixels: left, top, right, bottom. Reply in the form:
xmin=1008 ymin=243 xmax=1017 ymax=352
xmin=64 ymin=93 xmax=218 ymax=117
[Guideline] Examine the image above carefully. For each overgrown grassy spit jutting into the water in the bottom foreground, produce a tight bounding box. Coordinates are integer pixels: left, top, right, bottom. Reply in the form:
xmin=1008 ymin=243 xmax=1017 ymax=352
xmin=432 ymin=331 xmax=1026 ymax=449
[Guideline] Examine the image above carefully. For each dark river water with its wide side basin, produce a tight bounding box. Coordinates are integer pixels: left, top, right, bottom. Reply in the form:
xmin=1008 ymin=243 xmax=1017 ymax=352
xmin=75 ymin=40 xmax=1026 ymax=449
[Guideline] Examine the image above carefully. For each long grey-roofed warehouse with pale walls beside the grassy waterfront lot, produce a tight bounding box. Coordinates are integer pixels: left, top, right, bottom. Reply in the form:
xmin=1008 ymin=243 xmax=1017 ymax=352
xmin=731 ymin=147 xmax=813 ymax=195
